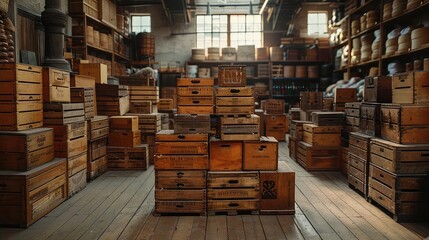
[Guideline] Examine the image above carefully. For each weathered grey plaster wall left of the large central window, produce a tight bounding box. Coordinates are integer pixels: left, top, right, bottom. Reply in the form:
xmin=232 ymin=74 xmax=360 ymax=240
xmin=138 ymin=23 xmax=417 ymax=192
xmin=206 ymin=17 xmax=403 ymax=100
xmin=129 ymin=5 xmax=195 ymax=66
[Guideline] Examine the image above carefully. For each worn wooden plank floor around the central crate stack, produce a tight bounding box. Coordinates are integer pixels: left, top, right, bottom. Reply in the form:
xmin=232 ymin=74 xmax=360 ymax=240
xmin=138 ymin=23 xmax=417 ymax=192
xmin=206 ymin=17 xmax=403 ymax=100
xmin=0 ymin=143 xmax=429 ymax=240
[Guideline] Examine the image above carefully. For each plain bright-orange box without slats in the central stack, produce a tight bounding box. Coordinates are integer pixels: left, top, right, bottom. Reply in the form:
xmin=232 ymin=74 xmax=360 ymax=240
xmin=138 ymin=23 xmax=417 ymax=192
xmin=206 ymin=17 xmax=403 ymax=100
xmin=209 ymin=138 xmax=243 ymax=171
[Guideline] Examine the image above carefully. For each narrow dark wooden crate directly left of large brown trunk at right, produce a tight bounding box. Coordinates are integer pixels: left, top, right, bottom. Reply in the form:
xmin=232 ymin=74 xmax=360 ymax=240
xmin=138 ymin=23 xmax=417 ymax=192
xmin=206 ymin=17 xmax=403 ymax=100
xmin=359 ymin=103 xmax=381 ymax=137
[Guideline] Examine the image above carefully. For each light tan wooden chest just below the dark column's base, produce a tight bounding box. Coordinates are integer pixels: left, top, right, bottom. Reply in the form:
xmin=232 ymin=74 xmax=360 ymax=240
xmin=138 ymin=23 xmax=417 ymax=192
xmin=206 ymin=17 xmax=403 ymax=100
xmin=43 ymin=67 xmax=70 ymax=103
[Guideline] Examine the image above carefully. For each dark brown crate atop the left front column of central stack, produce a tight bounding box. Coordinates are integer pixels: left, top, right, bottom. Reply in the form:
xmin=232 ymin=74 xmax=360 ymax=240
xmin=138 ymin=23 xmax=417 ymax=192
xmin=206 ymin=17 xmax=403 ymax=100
xmin=174 ymin=114 xmax=211 ymax=134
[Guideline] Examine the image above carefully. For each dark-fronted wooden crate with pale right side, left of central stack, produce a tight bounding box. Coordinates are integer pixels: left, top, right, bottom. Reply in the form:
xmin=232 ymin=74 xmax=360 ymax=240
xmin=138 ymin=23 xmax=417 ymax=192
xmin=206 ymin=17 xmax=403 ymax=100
xmin=97 ymin=96 xmax=130 ymax=116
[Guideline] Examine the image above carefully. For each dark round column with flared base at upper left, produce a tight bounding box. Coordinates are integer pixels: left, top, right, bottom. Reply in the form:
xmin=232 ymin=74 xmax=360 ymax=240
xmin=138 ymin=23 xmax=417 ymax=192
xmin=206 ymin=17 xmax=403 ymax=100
xmin=42 ymin=0 xmax=71 ymax=71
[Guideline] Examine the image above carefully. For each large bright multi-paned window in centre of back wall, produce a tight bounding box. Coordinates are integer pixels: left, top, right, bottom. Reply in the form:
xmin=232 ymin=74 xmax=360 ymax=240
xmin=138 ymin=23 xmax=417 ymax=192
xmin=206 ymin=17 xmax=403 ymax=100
xmin=196 ymin=15 xmax=262 ymax=48
